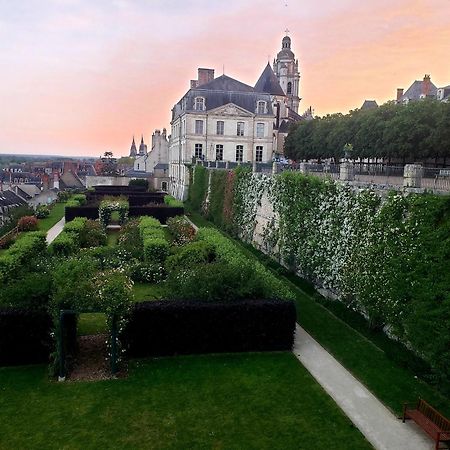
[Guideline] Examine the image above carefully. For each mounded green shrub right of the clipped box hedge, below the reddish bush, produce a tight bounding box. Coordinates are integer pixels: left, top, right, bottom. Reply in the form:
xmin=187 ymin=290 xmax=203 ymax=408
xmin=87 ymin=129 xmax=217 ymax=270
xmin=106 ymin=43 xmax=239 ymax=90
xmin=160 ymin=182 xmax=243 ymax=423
xmin=166 ymin=241 xmax=216 ymax=272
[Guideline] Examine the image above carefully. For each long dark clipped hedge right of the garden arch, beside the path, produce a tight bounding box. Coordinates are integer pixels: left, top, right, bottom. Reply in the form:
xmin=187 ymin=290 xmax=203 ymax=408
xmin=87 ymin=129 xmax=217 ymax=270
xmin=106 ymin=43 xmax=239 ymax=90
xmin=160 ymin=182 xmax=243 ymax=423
xmin=123 ymin=300 xmax=296 ymax=357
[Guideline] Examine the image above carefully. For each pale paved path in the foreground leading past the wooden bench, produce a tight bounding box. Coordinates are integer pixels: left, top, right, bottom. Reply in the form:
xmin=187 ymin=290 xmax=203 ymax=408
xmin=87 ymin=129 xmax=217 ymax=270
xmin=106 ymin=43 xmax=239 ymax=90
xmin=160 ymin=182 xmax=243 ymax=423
xmin=294 ymin=325 xmax=434 ymax=450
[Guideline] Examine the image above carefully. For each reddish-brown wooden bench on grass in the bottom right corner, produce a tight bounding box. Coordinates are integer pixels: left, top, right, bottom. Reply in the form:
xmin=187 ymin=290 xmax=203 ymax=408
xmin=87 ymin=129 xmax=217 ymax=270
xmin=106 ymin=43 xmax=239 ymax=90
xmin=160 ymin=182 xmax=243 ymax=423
xmin=403 ymin=398 xmax=450 ymax=450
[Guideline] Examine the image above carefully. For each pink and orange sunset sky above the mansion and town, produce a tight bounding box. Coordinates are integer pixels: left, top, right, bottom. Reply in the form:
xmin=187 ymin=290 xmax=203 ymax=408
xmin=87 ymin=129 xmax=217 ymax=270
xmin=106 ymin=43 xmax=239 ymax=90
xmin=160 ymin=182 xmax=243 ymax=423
xmin=0 ymin=0 xmax=450 ymax=156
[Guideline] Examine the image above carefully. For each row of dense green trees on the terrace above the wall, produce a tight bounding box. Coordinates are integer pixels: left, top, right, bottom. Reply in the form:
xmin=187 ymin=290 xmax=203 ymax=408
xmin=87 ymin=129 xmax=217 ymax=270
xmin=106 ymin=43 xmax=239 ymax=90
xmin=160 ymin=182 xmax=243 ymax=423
xmin=285 ymin=100 xmax=450 ymax=165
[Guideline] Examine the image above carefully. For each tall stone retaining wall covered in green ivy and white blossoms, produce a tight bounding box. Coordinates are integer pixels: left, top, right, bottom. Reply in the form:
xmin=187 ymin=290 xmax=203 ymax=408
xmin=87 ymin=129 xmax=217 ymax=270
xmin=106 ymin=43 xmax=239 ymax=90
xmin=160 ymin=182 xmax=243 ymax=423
xmin=190 ymin=166 xmax=450 ymax=381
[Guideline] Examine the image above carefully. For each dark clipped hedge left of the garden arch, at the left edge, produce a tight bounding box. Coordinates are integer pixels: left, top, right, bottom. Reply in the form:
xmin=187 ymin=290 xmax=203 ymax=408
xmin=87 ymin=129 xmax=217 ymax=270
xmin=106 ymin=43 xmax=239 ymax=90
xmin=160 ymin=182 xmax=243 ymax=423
xmin=0 ymin=308 xmax=53 ymax=365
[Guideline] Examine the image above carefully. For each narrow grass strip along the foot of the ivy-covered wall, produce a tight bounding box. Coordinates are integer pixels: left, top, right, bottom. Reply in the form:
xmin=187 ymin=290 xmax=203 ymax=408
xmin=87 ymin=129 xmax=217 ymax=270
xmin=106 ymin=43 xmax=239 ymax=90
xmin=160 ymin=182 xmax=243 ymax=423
xmin=186 ymin=209 xmax=450 ymax=417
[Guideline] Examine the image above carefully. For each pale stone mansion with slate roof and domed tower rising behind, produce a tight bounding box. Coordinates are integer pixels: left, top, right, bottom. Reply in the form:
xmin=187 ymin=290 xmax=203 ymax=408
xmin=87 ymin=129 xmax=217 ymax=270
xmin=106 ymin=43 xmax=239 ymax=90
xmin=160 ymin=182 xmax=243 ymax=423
xmin=169 ymin=36 xmax=302 ymax=199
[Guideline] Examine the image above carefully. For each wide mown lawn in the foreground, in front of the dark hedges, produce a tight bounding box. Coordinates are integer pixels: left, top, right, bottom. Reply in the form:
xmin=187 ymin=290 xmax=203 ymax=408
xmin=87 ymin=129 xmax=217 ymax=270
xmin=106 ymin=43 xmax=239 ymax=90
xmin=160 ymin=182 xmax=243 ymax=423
xmin=0 ymin=353 xmax=371 ymax=450
